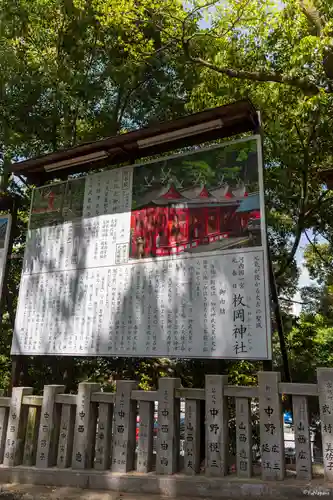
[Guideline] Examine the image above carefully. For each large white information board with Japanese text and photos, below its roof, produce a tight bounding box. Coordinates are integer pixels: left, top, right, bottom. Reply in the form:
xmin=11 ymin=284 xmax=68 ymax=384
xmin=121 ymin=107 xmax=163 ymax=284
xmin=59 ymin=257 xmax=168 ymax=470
xmin=12 ymin=136 xmax=271 ymax=359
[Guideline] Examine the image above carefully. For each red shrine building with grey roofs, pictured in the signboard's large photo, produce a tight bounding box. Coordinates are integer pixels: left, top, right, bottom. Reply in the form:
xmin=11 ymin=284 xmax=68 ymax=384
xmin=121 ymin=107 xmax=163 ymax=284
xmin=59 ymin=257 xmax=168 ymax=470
xmin=131 ymin=183 xmax=260 ymax=258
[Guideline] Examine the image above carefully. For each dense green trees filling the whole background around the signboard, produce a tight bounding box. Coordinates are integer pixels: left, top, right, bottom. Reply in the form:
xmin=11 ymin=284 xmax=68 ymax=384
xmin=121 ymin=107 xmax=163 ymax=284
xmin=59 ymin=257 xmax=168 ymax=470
xmin=0 ymin=0 xmax=333 ymax=390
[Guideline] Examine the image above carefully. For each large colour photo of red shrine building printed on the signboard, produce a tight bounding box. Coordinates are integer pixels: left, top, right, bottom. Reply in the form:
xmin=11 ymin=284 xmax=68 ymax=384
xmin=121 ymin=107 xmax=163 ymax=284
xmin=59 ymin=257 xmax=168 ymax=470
xmin=130 ymin=141 xmax=261 ymax=259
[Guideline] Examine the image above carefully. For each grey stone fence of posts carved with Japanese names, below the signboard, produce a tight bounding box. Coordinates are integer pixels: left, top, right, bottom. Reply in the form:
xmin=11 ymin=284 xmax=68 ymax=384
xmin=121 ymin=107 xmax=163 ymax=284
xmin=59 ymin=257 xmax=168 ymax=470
xmin=0 ymin=368 xmax=333 ymax=494
